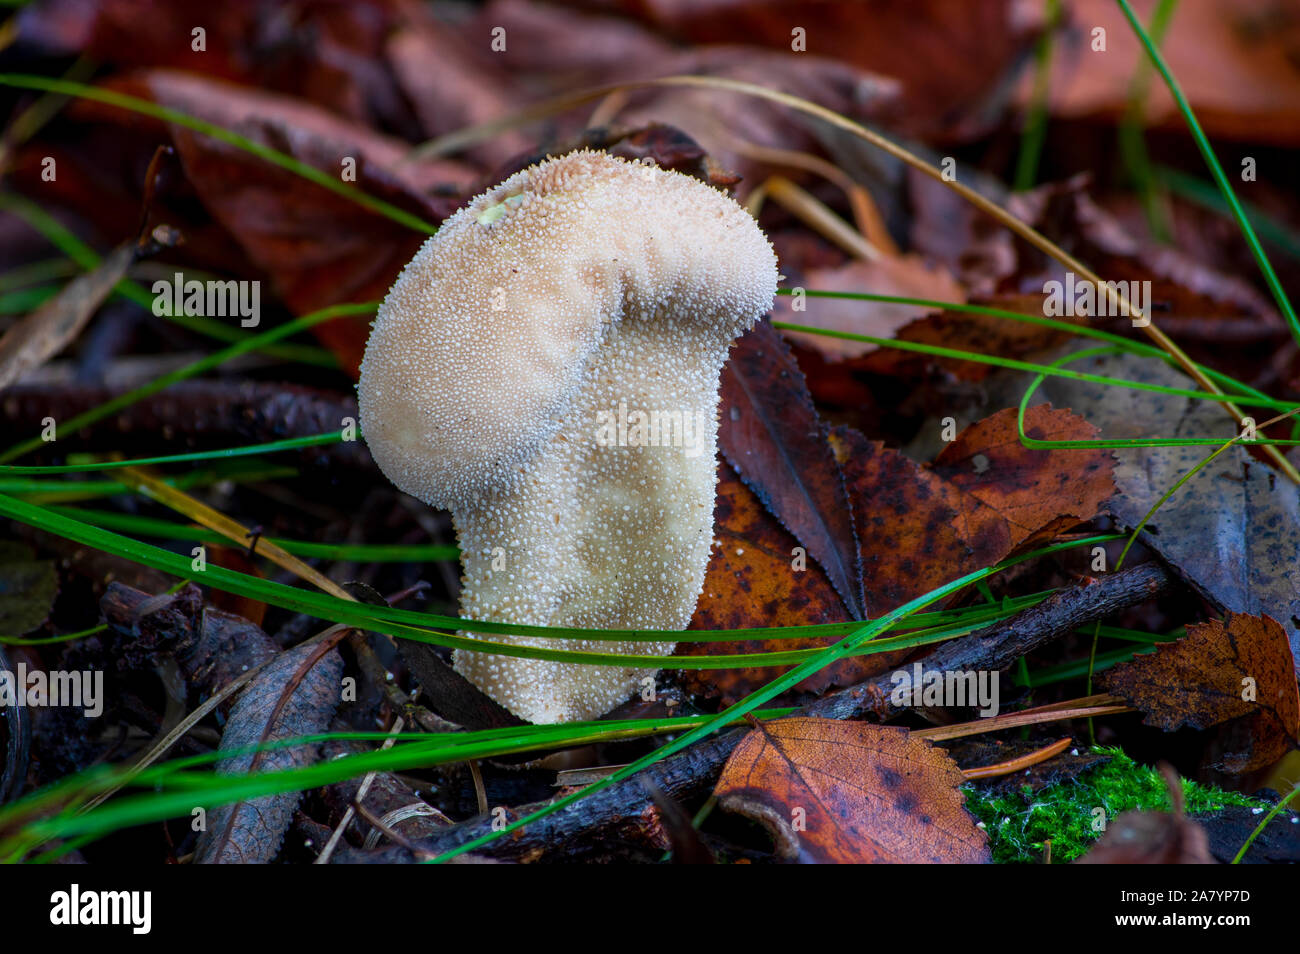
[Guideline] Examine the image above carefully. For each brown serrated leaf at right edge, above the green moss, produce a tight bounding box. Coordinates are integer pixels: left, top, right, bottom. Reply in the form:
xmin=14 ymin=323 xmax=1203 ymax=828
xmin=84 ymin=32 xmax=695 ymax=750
xmin=1100 ymin=612 xmax=1300 ymax=775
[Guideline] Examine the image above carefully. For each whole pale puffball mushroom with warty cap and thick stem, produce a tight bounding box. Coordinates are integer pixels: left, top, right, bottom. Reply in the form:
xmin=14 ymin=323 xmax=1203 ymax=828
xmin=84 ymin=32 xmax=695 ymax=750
xmin=358 ymin=151 xmax=776 ymax=723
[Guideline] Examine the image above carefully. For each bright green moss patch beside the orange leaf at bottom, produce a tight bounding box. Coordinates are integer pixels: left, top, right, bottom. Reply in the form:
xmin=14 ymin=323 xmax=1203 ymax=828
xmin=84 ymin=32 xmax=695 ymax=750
xmin=965 ymin=747 xmax=1268 ymax=864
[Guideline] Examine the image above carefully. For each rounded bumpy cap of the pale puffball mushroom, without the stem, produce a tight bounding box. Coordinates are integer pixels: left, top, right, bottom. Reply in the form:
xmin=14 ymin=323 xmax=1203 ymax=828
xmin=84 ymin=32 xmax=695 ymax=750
xmin=359 ymin=151 xmax=776 ymax=508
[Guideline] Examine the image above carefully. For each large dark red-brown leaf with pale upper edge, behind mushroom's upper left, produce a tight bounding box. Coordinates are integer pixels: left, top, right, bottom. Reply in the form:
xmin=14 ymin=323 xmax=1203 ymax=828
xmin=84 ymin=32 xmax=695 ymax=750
xmin=83 ymin=70 xmax=471 ymax=370
